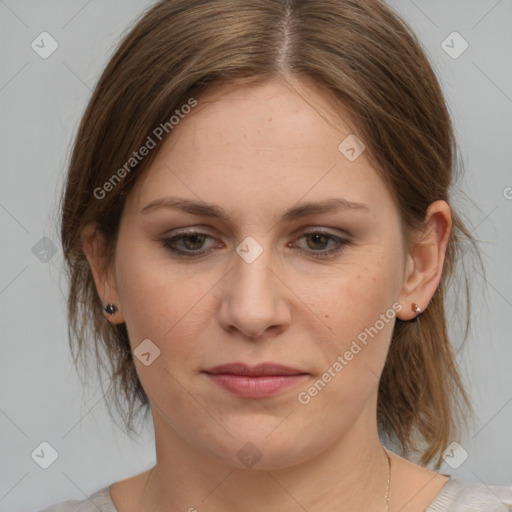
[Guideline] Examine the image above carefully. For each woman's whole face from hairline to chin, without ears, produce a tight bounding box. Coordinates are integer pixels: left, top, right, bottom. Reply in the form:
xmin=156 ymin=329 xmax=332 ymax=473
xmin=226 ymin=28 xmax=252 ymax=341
xmin=103 ymin=81 xmax=405 ymax=469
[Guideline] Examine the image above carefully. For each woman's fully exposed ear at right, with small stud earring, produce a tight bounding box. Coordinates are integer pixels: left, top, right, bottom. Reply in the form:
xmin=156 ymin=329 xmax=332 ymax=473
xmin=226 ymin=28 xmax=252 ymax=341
xmin=397 ymin=200 xmax=452 ymax=320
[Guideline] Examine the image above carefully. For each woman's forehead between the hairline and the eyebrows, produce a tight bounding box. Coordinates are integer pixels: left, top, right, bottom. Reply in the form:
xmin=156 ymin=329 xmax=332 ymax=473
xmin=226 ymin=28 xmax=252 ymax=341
xmin=126 ymin=80 xmax=389 ymax=219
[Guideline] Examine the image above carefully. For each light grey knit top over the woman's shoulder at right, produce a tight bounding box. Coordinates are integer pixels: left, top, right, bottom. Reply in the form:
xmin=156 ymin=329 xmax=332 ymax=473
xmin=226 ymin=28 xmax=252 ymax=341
xmin=425 ymin=476 xmax=512 ymax=512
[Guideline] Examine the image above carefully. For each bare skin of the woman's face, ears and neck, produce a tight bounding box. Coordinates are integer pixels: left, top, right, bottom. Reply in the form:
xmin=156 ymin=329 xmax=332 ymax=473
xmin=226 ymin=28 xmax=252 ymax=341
xmin=82 ymin=80 xmax=451 ymax=512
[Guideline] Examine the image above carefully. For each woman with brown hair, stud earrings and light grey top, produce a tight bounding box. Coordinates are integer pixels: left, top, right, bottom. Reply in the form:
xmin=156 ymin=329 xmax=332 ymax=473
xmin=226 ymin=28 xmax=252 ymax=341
xmin=39 ymin=0 xmax=512 ymax=512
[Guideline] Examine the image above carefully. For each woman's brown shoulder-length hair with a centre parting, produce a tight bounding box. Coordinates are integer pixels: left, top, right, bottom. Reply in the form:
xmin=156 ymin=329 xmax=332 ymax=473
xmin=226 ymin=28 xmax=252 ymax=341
xmin=61 ymin=0 xmax=484 ymax=468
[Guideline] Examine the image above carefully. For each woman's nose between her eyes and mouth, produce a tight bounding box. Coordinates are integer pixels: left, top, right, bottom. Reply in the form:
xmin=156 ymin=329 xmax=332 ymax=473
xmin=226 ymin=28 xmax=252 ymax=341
xmin=219 ymin=241 xmax=291 ymax=341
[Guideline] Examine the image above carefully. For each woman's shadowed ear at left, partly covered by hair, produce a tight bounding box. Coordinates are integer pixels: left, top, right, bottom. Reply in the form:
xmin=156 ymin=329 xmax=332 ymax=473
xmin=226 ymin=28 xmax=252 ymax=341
xmin=80 ymin=222 xmax=124 ymax=324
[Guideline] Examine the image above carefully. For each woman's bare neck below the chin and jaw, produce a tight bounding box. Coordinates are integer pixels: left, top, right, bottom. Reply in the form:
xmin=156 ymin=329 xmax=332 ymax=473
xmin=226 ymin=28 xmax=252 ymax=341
xmin=139 ymin=406 xmax=389 ymax=512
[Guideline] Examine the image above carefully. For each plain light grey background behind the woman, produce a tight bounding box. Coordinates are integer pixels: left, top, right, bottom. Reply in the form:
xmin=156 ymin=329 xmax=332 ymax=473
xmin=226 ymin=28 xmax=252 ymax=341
xmin=0 ymin=0 xmax=512 ymax=511
